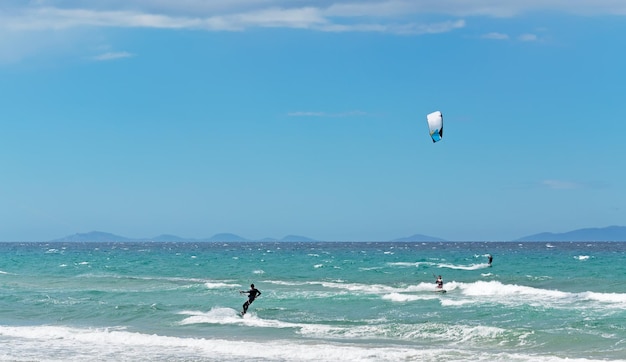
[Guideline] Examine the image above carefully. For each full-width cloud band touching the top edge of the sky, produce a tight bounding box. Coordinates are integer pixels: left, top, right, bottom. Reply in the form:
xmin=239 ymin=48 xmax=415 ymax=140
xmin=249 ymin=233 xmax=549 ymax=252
xmin=0 ymin=0 xmax=626 ymax=36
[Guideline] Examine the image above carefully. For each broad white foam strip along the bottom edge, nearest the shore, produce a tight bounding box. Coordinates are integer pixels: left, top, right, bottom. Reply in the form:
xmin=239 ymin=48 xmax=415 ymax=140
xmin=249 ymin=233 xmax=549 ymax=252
xmin=0 ymin=326 xmax=516 ymax=361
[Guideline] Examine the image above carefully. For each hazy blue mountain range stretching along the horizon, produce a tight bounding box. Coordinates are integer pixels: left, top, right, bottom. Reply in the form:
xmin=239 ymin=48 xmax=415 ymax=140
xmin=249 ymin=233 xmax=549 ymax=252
xmin=51 ymin=226 xmax=626 ymax=242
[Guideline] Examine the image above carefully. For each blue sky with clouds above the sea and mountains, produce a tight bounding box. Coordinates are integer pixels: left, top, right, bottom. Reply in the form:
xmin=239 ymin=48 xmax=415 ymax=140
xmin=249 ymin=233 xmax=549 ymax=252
xmin=0 ymin=0 xmax=626 ymax=241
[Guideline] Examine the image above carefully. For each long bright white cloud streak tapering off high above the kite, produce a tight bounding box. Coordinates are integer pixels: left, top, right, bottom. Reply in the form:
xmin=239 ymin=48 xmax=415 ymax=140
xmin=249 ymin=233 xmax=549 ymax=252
xmin=0 ymin=7 xmax=465 ymax=34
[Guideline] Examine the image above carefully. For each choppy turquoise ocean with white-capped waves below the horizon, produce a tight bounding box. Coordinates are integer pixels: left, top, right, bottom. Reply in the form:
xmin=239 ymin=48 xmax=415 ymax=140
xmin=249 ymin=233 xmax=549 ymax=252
xmin=0 ymin=242 xmax=626 ymax=362
